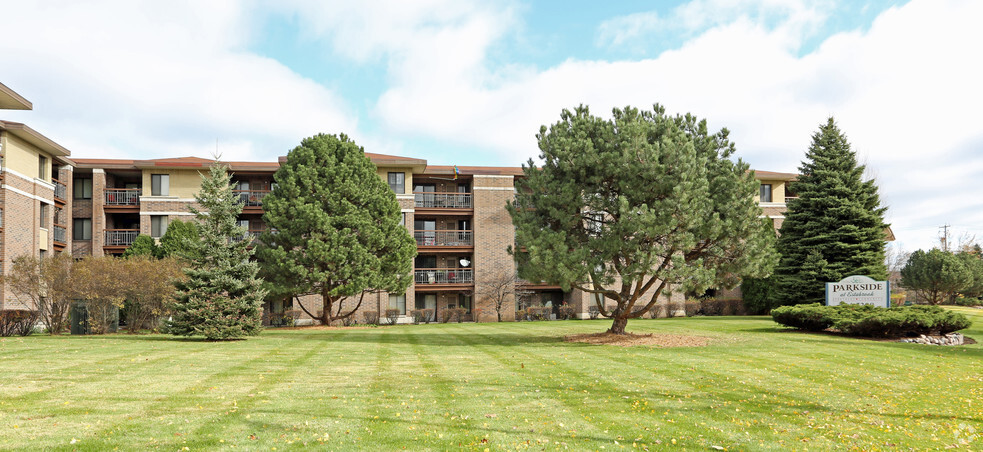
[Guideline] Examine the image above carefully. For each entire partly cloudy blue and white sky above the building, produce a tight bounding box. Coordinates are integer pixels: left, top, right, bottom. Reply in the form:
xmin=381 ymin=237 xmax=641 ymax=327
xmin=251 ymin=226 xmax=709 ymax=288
xmin=0 ymin=0 xmax=983 ymax=250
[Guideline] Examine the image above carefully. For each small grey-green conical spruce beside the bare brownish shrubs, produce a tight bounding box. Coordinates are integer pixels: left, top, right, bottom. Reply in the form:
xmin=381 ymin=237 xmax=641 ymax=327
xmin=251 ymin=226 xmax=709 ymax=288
xmin=168 ymin=163 xmax=266 ymax=340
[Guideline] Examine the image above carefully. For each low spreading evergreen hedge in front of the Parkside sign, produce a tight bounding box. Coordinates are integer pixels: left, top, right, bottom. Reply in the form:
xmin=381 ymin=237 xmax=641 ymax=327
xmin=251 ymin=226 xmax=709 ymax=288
xmin=771 ymin=303 xmax=972 ymax=337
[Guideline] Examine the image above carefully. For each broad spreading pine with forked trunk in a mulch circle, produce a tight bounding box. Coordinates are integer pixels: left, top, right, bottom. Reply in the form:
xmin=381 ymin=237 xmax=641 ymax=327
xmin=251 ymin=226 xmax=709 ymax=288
xmin=508 ymin=105 xmax=774 ymax=334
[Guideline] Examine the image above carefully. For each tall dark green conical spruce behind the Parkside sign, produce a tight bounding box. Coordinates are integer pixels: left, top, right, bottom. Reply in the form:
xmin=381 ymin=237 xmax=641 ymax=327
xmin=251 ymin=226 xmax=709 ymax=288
xmin=774 ymin=117 xmax=887 ymax=305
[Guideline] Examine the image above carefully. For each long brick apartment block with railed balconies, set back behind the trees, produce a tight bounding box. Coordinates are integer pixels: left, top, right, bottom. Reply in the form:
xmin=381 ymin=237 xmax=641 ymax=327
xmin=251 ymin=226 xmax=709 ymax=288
xmin=70 ymin=153 xmax=795 ymax=322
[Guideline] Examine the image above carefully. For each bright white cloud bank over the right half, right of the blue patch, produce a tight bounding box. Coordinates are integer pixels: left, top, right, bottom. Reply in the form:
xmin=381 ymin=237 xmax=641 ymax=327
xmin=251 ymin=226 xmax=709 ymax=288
xmin=358 ymin=0 xmax=983 ymax=251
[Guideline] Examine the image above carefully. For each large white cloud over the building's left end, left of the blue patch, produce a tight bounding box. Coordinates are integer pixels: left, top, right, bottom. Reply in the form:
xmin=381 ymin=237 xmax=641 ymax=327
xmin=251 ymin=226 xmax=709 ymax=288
xmin=0 ymin=1 xmax=357 ymax=160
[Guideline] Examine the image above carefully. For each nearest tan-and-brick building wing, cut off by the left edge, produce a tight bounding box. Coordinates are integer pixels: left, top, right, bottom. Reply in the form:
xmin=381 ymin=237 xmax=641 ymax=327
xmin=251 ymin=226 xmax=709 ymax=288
xmin=0 ymin=84 xmax=72 ymax=309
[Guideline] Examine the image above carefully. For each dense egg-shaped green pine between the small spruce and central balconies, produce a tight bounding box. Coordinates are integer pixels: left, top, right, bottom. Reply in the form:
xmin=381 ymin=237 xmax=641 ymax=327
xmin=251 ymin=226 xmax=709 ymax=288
xmin=257 ymin=134 xmax=416 ymax=325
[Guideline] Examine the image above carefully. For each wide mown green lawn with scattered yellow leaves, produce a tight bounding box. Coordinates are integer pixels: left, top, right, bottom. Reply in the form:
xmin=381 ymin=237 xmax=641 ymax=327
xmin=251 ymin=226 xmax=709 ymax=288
xmin=0 ymin=309 xmax=983 ymax=450
